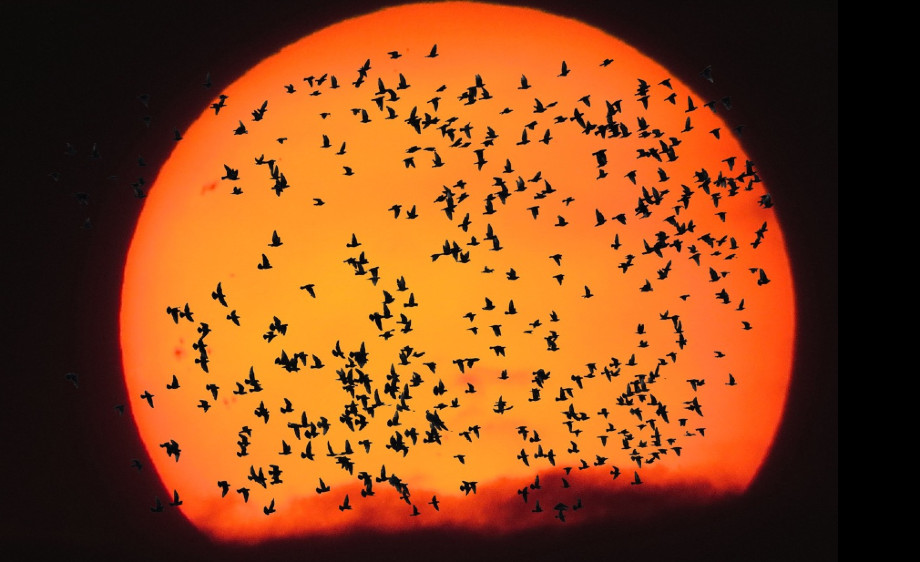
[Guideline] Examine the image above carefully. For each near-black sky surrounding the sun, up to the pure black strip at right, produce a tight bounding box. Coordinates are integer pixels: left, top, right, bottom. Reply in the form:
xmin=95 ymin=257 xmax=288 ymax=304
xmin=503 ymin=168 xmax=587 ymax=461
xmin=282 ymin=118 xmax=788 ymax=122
xmin=0 ymin=0 xmax=838 ymax=560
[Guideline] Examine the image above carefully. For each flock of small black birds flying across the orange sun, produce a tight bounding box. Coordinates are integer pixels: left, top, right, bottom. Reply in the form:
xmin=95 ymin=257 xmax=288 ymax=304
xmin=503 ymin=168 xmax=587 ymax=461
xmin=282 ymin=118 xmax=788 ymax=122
xmin=61 ymin=37 xmax=773 ymax=522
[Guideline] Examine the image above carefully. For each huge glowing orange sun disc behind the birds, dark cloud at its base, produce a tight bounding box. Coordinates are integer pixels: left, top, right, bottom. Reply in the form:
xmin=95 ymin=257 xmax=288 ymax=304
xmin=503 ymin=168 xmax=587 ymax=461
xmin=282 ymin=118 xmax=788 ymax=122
xmin=121 ymin=3 xmax=795 ymax=541
